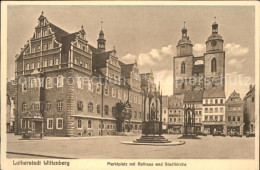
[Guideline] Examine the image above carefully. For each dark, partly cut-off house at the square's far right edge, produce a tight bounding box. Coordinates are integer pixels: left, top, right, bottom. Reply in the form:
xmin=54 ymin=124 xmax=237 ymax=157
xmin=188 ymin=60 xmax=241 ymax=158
xmin=243 ymin=85 xmax=256 ymax=134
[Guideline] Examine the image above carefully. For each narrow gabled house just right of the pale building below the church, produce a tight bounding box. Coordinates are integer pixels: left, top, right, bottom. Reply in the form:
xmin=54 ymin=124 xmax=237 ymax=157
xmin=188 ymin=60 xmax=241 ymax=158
xmin=226 ymin=91 xmax=244 ymax=135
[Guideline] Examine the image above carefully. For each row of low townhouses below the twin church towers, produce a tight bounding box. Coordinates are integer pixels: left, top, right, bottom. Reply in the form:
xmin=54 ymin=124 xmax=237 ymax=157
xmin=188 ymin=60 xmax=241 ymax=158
xmin=163 ymin=85 xmax=255 ymax=135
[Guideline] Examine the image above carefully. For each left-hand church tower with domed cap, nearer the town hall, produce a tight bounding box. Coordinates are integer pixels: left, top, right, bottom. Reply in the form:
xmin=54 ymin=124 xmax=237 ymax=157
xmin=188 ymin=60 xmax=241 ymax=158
xmin=173 ymin=22 xmax=193 ymax=94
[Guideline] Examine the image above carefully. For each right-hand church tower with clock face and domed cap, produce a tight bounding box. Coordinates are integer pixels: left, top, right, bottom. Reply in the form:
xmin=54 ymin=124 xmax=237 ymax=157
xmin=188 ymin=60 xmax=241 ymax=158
xmin=204 ymin=17 xmax=225 ymax=90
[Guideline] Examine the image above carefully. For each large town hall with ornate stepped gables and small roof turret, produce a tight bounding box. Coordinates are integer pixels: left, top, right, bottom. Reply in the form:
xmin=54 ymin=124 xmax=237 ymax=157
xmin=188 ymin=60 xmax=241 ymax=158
xmin=15 ymin=13 xmax=148 ymax=136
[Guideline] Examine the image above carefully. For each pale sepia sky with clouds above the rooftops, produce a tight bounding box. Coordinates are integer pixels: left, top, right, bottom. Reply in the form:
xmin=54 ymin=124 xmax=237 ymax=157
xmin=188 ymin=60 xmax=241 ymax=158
xmin=7 ymin=5 xmax=255 ymax=98
